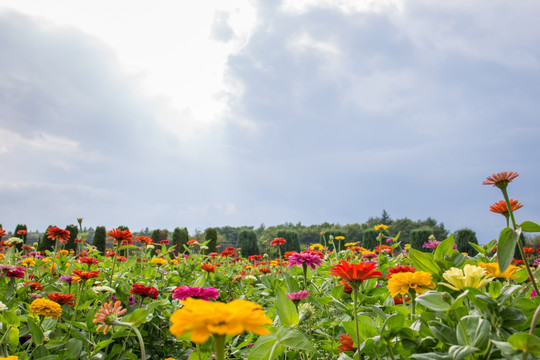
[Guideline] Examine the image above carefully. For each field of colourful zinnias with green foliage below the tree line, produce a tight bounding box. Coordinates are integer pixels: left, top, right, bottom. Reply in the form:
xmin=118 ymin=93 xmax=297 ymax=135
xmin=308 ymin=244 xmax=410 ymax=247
xmin=0 ymin=172 xmax=540 ymax=360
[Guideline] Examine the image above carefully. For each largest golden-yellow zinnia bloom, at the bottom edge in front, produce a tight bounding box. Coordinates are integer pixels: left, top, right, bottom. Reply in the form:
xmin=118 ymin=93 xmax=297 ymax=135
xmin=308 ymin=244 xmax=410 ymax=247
xmin=169 ymin=298 xmax=272 ymax=344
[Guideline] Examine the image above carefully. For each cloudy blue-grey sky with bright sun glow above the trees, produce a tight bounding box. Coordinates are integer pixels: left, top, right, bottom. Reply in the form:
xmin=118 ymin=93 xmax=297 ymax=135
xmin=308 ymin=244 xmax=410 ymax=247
xmin=0 ymin=0 xmax=540 ymax=243
